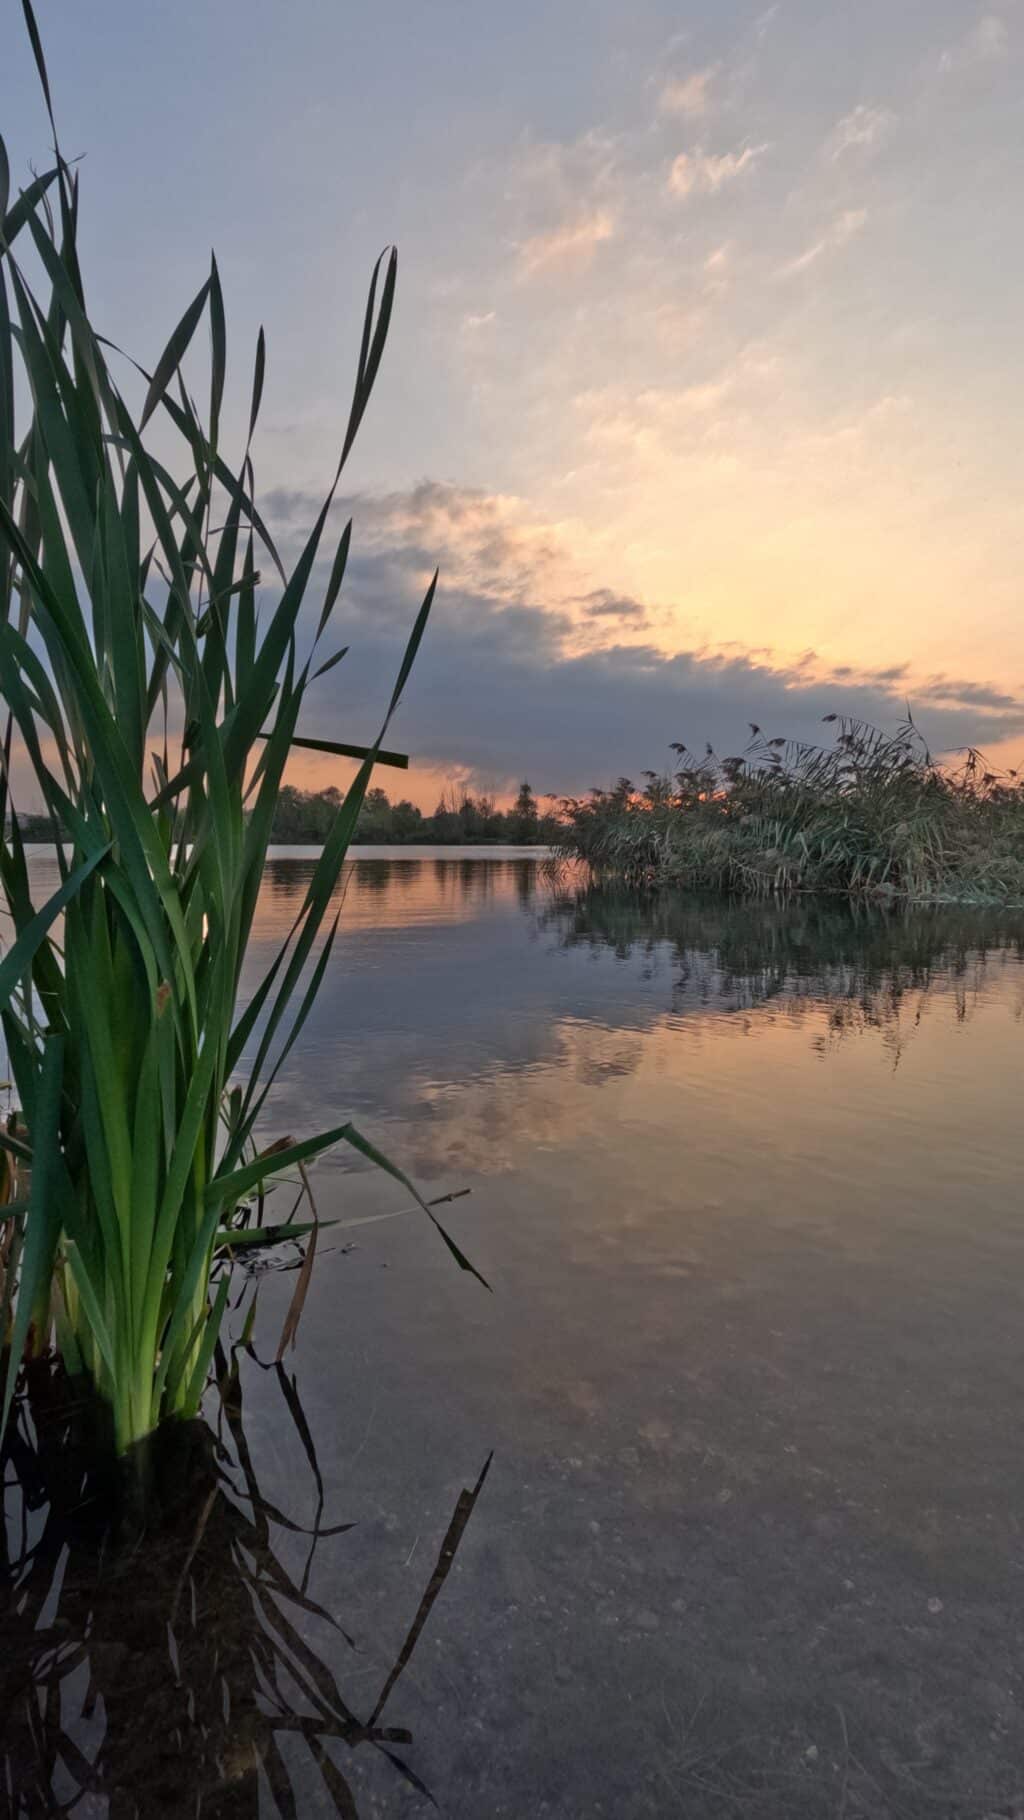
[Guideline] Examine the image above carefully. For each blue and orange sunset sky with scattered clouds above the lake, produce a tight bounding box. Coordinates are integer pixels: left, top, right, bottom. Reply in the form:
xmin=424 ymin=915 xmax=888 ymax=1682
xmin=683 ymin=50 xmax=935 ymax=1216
xmin=0 ymin=0 xmax=1024 ymax=808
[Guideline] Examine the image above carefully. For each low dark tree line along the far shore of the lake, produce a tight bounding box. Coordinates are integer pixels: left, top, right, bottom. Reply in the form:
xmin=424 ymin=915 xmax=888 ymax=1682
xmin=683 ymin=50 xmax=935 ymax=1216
xmin=271 ymin=783 xmax=564 ymax=846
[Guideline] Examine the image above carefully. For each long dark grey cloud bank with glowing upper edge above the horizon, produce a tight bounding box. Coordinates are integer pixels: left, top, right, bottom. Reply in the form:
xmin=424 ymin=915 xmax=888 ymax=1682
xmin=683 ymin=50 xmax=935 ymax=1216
xmin=258 ymin=482 xmax=1024 ymax=792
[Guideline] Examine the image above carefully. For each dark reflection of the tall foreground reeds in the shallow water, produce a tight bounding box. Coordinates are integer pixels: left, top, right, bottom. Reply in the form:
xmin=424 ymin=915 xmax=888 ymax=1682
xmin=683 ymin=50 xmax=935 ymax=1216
xmin=0 ymin=1360 xmax=489 ymax=1820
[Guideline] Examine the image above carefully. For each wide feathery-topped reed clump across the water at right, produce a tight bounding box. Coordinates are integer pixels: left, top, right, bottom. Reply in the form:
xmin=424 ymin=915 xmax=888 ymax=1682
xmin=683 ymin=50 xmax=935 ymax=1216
xmin=562 ymin=715 xmax=1024 ymax=903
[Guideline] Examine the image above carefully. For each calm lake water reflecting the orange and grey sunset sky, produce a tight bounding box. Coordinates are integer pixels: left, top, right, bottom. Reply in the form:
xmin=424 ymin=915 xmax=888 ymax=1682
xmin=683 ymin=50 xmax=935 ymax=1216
xmin=0 ymin=848 xmax=1024 ymax=1820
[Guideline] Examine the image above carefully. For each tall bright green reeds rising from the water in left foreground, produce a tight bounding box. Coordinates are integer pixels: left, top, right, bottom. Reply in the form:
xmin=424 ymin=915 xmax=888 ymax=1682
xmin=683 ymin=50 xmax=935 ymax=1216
xmin=0 ymin=0 xmax=471 ymax=1451
